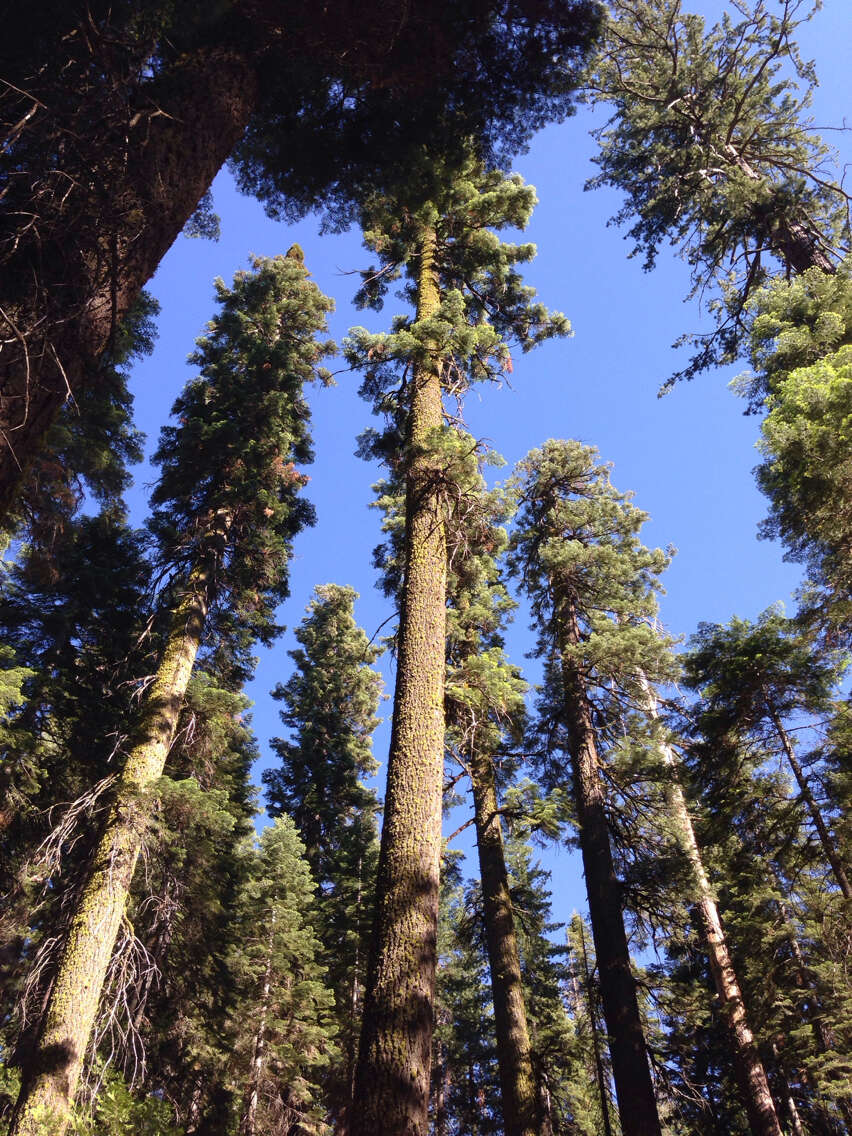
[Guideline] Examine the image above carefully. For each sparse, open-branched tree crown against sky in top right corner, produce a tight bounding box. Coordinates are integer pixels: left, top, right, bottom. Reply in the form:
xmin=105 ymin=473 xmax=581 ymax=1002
xmin=588 ymin=0 xmax=849 ymax=382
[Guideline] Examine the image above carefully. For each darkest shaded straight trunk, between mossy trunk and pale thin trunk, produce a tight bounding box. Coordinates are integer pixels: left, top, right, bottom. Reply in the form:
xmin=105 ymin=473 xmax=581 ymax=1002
xmin=560 ymin=595 xmax=660 ymax=1136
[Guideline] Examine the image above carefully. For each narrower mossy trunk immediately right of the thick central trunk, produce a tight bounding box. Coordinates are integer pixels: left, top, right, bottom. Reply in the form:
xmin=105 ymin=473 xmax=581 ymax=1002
xmin=469 ymin=754 xmax=540 ymax=1136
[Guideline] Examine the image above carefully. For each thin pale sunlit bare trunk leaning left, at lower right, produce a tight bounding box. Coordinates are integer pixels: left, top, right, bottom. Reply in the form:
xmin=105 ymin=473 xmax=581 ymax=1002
xmin=642 ymin=676 xmax=782 ymax=1136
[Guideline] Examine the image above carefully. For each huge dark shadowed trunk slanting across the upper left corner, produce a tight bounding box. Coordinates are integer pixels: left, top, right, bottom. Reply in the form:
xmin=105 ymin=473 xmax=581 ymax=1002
xmin=0 ymin=49 xmax=257 ymax=520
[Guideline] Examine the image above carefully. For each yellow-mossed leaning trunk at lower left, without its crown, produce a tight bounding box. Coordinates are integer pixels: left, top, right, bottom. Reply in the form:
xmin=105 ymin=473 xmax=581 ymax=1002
xmin=9 ymin=569 xmax=208 ymax=1136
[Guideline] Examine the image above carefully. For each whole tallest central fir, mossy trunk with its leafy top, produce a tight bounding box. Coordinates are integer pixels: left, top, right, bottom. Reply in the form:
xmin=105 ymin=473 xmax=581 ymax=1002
xmin=346 ymin=156 xmax=567 ymax=1134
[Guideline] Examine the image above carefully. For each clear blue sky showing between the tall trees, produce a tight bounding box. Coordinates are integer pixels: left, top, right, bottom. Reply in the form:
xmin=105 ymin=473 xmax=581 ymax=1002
xmin=123 ymin=0 xmax=852 ymax=919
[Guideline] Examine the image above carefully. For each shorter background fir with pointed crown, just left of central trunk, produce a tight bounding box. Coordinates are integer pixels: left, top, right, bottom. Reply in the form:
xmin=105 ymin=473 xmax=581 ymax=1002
xmin=264 ymin=584 xmax=382 ymax=1130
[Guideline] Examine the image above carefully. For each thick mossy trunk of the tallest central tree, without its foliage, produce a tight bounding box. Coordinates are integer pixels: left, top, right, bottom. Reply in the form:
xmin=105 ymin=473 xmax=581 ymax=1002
xmin=352 ymin=223 xmax=446 ymax=1136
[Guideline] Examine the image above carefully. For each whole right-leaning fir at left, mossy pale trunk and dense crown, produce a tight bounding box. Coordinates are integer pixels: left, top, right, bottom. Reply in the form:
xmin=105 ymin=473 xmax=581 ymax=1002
xmin=11 ymin=257 xmax=331 ymax=1136
